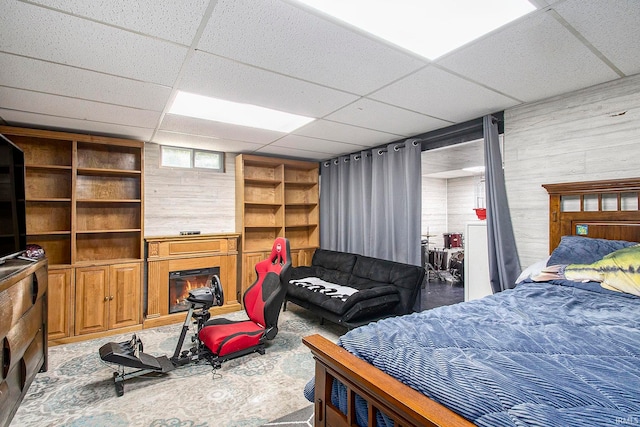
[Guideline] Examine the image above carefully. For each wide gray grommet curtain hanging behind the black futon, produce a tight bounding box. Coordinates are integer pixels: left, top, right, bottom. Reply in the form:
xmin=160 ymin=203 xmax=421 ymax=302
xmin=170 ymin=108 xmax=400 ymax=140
xmin=320 ymin=140 xmax=422 ymax=265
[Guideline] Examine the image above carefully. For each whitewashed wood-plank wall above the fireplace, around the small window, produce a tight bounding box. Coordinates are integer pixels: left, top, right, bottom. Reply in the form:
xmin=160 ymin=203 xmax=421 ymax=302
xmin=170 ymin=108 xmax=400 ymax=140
xmin=144 ymin=143 xmax=236 ymax=236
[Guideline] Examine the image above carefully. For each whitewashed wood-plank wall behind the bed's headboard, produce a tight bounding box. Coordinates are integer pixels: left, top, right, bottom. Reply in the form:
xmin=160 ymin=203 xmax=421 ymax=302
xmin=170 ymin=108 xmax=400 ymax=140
xmin=503 ymin=75 xmax=640 ymax=268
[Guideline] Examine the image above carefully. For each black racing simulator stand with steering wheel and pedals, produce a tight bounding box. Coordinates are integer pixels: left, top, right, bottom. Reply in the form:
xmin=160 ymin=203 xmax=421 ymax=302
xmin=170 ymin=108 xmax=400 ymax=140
xmin=99 ymin=276 xmax=224 ymax=396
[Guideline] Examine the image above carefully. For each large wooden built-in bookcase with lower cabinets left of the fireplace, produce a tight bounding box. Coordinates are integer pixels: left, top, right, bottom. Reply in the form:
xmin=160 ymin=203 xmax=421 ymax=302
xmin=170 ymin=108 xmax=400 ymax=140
xmin=0 ymin=126 xmax=144 ymax=342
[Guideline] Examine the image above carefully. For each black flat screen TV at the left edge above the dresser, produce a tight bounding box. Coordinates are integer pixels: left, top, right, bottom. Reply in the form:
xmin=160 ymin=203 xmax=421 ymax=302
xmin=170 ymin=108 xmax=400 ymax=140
xmin=0 ymin=135 xmax=27 ymax=258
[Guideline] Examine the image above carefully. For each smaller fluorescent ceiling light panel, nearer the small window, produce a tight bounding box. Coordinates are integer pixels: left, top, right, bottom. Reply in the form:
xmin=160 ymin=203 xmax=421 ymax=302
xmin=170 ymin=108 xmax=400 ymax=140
xmin=169 ymin=91 xmax=315 ymax=133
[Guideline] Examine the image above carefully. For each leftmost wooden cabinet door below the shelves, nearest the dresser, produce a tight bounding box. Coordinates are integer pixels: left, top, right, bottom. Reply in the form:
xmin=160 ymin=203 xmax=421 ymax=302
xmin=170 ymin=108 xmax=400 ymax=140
xmin=47 ymin=268 xmax=73 ymax=340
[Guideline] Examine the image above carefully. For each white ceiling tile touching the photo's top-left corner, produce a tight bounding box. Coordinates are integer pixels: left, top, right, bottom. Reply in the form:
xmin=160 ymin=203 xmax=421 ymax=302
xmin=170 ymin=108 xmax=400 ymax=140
xmin=0 ymin=1 xmax=187 ymax=86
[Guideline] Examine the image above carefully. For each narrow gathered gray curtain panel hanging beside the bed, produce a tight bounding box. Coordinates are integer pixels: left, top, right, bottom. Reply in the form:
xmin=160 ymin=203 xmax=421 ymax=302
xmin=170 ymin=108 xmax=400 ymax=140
xmin=483 ymin=116 xmax=520 ymax=293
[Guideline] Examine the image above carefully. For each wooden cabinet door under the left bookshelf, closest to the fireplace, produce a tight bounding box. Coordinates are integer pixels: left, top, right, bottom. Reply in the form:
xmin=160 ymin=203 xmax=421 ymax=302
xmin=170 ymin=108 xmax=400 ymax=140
xmin=109 ymin=263 xmax=141 ymax=329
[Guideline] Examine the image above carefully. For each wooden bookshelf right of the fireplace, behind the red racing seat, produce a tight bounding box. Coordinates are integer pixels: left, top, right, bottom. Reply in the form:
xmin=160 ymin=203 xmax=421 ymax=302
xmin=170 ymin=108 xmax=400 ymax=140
xmin=236 ymin=154 xmax=320 ymax=291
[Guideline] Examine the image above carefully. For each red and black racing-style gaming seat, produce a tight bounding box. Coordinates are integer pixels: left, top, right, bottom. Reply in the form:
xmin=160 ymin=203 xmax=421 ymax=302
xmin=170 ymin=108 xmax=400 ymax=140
xmin=198 ymin=237 xmax=291 ymax=367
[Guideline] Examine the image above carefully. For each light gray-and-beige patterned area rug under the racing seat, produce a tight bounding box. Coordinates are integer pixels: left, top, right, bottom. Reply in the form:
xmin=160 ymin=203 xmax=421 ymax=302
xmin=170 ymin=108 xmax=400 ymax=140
xmin=11 ymin=304 xmax=346 ymax=427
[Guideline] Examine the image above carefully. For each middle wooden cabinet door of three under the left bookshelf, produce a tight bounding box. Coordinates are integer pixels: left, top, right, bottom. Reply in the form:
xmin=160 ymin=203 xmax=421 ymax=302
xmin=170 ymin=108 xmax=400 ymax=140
xmin=75 ymin=266 xmax=110 ymax=335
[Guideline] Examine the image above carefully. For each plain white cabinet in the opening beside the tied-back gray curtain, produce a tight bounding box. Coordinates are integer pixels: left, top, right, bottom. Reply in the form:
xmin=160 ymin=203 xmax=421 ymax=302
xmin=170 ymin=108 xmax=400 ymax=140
xmin=464 ymin=221 xmax=493 ymax=301
